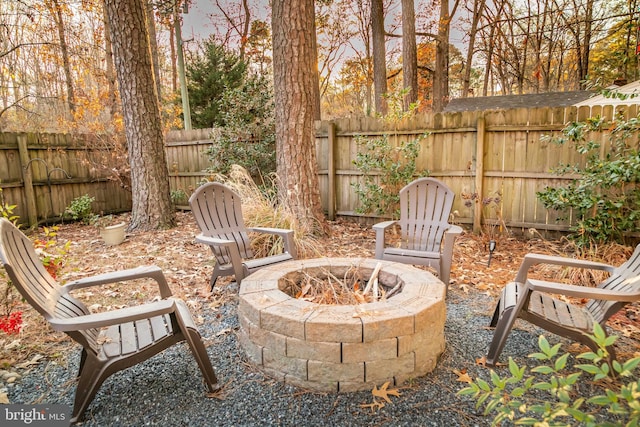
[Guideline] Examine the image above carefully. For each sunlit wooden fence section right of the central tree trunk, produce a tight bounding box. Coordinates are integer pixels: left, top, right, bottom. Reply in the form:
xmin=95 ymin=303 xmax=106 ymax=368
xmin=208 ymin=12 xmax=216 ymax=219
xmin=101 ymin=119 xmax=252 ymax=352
xmin=316 ymin=106 xmax=637 ymax=236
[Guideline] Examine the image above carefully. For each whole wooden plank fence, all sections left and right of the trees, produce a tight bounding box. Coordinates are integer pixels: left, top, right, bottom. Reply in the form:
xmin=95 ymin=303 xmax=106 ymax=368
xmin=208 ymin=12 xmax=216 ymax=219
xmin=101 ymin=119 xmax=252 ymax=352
xmin=0 ymin=106 xmax=637 ymax=231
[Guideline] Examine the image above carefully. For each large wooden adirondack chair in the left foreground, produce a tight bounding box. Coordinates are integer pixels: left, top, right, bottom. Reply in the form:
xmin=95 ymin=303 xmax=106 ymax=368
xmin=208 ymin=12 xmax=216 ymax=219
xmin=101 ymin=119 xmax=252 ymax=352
xmin=0 ymin=218 xmax=219 ymax=423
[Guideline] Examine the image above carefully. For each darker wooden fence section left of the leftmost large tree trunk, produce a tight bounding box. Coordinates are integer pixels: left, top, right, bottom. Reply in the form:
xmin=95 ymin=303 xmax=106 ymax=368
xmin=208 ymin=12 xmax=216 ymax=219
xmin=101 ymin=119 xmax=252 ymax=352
xmin=0 ymin=133 xmax=131 ymax=225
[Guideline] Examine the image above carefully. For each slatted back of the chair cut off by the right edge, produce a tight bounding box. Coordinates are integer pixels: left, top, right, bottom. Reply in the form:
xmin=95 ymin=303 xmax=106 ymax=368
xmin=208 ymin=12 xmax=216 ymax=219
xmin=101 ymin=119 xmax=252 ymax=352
xmin=586 ymin=245 xmax=640 ymax=323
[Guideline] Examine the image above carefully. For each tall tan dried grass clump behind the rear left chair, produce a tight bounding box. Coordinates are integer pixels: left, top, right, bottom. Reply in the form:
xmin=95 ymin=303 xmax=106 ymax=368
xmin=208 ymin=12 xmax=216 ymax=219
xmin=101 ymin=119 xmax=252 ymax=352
xmin=216 ymin=165 xmax=322 ymax=258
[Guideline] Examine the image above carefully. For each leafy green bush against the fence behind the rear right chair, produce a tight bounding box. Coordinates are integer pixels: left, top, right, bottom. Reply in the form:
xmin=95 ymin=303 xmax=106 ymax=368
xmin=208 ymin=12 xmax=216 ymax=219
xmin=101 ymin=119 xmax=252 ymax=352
xmin=352 ymin=133 xmax=429 ymax=218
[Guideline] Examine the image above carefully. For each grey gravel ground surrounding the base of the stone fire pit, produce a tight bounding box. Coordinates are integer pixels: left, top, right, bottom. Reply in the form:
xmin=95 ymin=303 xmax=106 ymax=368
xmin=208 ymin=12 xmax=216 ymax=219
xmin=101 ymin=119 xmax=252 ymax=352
xmin=8 ymin=284 xmax=559 ymax=426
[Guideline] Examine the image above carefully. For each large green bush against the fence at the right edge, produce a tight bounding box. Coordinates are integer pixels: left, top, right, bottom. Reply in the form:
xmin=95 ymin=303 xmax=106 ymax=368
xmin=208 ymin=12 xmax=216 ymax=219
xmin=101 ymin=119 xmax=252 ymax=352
xmin=537 ymin=117 xmax=640 ymax=248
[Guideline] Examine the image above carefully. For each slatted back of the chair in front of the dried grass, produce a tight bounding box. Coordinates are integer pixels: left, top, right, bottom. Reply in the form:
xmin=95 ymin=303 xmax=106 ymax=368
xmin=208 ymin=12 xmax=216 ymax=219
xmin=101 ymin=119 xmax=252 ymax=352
xmin=189 ymin=182 xmax=254 ymax=264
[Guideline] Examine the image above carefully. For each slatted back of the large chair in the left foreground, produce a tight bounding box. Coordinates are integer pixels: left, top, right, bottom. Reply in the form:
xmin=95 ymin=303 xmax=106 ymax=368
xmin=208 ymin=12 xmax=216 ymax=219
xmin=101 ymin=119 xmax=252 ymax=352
xmin=0 ymin=218 xmax=99 ymax=351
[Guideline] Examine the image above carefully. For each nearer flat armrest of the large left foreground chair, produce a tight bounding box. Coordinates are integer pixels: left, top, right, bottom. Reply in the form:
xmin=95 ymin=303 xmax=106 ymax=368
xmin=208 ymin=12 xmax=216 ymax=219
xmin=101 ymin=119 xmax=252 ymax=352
xmin=49 ymin=299 xmax=176 ymax=332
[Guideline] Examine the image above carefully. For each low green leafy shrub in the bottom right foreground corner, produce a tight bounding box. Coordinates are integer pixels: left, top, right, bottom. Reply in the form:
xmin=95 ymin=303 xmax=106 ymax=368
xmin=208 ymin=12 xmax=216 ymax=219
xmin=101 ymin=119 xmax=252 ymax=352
xmin=458 ymin=323 xmax=640 ymax=426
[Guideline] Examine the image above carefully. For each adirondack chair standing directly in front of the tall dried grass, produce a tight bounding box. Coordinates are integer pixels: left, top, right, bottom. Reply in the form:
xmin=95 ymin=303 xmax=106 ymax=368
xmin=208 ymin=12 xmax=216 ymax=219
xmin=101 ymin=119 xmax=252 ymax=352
xmin=189 ymin=182 xmax=297 ymax=289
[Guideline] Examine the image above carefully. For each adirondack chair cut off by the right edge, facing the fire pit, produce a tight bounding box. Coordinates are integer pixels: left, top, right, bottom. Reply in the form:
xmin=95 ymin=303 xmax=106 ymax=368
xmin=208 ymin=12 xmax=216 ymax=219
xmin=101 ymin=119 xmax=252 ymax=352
xmin=487 ymin=249 xmax=640 ymax=365
